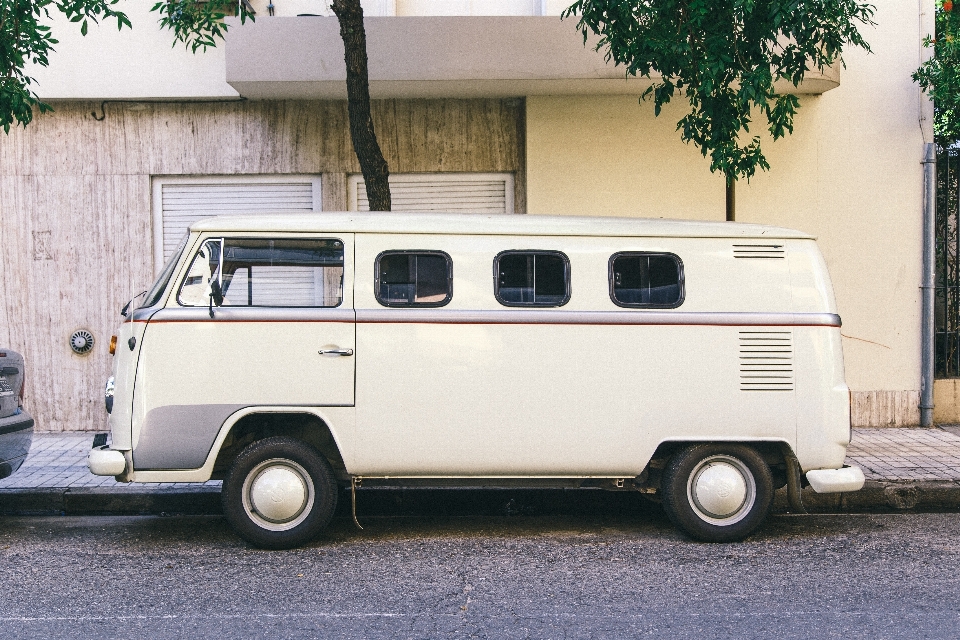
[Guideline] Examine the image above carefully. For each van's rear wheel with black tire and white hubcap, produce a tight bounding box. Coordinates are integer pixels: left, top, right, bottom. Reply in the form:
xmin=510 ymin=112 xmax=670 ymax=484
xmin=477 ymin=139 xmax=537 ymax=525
xmin=660 ymin=444 xmax=773 ymax=542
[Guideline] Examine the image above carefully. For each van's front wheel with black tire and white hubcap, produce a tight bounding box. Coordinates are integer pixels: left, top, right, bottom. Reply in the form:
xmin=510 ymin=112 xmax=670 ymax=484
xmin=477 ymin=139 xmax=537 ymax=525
xmin=221 ymin=436 xmax=337 ymax=549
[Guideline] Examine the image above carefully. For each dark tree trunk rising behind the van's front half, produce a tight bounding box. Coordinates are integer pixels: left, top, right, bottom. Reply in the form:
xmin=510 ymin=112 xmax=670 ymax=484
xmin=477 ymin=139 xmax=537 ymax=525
xmin=330 ymin=0 xmax=390 ymax=211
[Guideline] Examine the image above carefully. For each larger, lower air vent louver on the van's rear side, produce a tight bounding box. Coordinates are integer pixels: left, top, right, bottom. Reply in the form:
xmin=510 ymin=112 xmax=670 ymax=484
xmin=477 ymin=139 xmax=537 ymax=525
xmin=740 ymin=331 xmax=793 ymax=391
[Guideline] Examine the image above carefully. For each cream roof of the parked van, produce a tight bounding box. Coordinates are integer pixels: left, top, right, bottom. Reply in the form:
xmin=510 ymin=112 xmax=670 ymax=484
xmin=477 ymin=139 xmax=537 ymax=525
xmin=190 ymin=211 xmax=813 ymax=239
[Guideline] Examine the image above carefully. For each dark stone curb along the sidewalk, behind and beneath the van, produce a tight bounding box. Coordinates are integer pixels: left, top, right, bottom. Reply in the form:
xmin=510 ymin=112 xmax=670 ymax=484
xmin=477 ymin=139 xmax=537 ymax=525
xmin=0 ymin=480 xmax=960 ymax=518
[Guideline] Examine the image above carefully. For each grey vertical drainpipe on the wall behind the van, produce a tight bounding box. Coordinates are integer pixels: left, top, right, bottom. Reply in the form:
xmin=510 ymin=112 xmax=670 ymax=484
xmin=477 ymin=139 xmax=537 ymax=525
xmin=920 ymin=143 xmax=937 ymax=427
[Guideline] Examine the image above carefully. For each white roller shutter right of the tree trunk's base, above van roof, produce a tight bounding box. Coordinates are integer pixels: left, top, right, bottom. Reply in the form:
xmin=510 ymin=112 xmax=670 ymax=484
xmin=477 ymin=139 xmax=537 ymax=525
xmin=348 ymin=173 xmax=513 ymax=213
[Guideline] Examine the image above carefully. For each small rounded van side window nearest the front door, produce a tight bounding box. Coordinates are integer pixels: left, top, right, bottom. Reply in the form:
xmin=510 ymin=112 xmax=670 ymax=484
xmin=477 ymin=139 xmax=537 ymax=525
xmin=374 ymin=251 xmax=453 ymax=307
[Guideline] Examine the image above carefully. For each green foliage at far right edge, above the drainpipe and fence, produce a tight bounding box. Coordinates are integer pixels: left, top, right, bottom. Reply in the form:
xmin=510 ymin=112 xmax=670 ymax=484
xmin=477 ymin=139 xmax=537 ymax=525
xmin=913 ymin=1 xmax=960 ymax=148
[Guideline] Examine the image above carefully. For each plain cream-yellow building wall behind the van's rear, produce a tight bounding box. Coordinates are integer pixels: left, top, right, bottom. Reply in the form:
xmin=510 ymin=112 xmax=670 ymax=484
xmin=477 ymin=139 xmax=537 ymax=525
xmin=527 ymin=2 xmax=928 ymax=425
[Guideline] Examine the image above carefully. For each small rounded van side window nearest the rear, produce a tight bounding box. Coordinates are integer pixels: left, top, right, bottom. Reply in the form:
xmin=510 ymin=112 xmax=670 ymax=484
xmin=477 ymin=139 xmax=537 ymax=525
xmin=610 ymin=253 xmax=683 ymax=308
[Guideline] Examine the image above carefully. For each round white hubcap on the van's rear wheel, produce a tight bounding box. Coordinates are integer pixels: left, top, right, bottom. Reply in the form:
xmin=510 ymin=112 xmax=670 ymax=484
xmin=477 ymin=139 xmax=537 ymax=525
xmin=687 ymin=456 xmax=757 ymax=525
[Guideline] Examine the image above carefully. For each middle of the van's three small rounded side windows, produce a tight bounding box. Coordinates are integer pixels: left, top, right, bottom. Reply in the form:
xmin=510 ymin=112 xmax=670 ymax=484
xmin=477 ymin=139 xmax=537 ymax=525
xmin=493 ymin=251 xmax=570 ymax=307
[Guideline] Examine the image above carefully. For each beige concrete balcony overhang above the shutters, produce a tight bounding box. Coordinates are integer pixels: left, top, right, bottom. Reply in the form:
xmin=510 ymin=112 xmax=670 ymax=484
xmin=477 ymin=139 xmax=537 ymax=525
xmin=226 ymin=16 xmax=840 ymax=100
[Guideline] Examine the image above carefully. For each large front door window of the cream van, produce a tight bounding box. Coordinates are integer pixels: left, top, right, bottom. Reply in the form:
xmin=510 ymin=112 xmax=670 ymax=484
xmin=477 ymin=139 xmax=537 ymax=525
xmin=178 ymin=238 xmax=343 ymax=307
